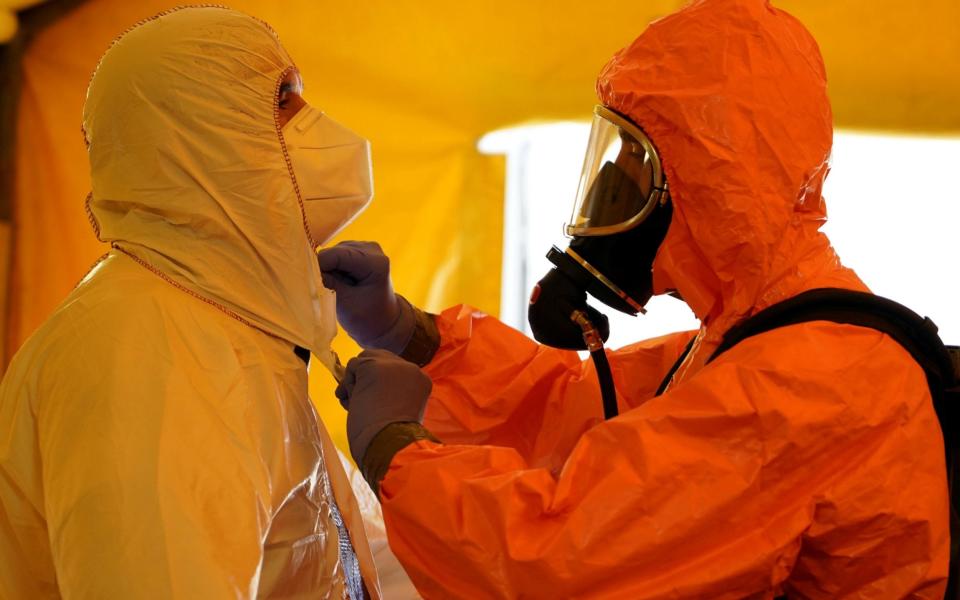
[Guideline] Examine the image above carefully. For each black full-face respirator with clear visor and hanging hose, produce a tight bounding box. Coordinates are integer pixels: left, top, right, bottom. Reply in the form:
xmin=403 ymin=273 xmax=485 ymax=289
xmin=528 ymin=106 xmax=673 ymax=418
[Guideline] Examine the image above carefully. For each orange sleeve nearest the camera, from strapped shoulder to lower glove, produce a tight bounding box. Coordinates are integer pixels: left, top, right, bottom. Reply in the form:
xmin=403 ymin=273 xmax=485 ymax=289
xmin=381 ymin=323 xmax=949 ymax=599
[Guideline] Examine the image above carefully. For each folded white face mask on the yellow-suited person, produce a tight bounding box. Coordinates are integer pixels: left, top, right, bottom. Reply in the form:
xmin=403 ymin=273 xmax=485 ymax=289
xmin=283 ymin=104 xmax=373 ymax=246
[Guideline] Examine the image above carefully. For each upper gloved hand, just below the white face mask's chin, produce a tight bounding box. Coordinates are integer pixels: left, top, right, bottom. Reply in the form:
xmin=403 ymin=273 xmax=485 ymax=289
xmin=317 ymin=242 xmax=416 ymax=354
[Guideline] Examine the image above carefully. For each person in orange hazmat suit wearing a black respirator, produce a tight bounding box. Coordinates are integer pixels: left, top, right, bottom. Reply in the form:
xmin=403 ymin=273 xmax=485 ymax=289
xmin=320 ymin=0 xmax=949 ymax=599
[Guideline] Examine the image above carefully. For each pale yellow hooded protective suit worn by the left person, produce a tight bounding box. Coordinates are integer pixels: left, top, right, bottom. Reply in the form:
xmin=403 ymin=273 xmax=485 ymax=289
xmin=0 ymin=8 xmax=380 ymax=599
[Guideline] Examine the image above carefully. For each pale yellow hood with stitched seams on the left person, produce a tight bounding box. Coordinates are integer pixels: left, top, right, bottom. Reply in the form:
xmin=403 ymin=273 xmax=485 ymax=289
xmin=83 ymin=7 xmax=336 ymax=365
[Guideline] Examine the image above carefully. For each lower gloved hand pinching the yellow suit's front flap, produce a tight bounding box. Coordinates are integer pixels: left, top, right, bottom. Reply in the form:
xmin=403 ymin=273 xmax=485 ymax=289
xmin=335 ymin=350 xmax=433 ymax=465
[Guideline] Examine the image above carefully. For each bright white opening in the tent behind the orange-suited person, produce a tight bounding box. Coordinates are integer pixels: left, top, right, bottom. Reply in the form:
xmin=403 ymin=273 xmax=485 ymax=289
xmin=480 ymin=123 xmax=960 ymax=348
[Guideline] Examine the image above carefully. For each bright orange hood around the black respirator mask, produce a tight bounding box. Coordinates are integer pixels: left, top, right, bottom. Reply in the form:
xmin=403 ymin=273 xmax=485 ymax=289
xmin=597 ymin=0 xmax=857 ymax=340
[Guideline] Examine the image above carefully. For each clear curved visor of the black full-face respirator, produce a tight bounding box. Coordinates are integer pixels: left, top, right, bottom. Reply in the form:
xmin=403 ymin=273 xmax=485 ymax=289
xmin=566 ymin=106 xmax=670 ymax=236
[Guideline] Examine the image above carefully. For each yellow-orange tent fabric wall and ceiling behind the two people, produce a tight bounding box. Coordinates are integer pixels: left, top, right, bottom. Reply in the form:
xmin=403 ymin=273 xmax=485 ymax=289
xmin=5 ymin=0 xmax=960 ymax=447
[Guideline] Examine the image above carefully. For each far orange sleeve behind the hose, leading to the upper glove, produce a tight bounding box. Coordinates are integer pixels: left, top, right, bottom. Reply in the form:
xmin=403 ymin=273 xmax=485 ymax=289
xmin=424 ymin=306 xmax=693 ymax=469
